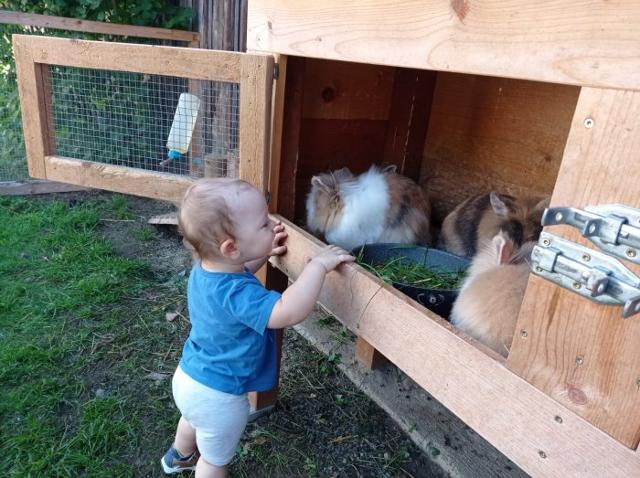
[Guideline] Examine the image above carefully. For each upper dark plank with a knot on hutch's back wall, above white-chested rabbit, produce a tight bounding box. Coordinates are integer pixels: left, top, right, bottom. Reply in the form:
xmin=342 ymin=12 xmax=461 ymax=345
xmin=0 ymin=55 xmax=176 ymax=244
xmin=302 ymin=59 xmax=395 ymax=120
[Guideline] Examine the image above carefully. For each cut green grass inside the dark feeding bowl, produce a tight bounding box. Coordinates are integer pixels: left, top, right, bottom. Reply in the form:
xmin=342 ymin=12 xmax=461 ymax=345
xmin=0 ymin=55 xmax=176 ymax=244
xmin=357 ymin=257 xmax=464 ymax=289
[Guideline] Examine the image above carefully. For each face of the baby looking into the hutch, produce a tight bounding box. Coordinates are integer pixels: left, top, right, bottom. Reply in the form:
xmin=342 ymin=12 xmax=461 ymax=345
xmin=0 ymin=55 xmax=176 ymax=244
xmin=229 ymin=190 xmax=274 ymax=262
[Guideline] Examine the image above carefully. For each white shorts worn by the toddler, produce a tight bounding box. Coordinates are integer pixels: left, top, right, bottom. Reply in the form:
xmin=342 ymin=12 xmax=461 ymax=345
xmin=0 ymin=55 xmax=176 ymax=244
xmin=173 ymin=367 xmax=249 ymax=466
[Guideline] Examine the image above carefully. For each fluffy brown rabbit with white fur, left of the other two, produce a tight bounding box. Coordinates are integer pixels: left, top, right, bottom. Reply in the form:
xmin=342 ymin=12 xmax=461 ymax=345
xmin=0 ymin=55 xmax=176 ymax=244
xmin=307 ymin=166 xmax=431 ymax=250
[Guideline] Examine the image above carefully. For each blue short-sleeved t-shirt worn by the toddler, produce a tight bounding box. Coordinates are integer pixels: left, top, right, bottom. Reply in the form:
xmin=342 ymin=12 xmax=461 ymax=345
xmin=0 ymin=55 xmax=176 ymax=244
xmin=180 ymin=262 xmax=280 ymax=395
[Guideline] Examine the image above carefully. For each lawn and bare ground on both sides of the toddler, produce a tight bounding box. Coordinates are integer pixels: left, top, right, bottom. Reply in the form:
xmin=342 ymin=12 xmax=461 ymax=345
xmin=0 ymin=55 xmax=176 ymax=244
xmin=0 ymin=194 xmax=433 ymax=477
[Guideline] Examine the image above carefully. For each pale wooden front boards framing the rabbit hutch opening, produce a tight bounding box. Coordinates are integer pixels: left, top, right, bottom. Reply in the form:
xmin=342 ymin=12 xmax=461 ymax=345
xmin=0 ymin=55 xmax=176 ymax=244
xmin=248 ymin=0 xmax=640 ymax=476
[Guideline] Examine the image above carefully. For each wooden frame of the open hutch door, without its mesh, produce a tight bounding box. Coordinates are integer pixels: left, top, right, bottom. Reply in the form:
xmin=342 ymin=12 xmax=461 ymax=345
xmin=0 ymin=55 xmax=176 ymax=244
xmin=13 ymin=35 xmax=273 ymax=201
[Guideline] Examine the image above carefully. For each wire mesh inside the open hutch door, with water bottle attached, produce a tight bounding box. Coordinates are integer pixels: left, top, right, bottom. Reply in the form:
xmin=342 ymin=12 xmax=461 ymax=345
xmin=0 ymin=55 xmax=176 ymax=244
xmin=51 ymin=66 xmax=239 ymax=177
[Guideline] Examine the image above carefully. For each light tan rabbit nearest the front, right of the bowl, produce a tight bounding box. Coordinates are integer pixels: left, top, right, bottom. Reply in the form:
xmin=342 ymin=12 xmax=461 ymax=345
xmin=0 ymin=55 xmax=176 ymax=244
xmin=451 ymin=231 xmax=535 ymax=357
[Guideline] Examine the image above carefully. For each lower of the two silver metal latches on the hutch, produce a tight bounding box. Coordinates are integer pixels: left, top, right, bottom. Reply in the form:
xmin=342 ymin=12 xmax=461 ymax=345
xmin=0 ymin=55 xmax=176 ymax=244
xmin=531 ymin=231 xmax=640 ymax=319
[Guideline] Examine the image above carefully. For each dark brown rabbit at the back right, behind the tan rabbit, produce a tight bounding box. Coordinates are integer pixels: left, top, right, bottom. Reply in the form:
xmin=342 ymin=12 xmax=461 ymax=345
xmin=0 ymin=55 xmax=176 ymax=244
xmin=438 ymin=191 xmax=549 ymax=257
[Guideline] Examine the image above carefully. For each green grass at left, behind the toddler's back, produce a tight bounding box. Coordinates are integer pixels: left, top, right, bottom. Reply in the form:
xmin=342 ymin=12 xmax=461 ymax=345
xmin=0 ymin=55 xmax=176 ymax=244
xmin=0 ymin=197 xmax=183 ymax=477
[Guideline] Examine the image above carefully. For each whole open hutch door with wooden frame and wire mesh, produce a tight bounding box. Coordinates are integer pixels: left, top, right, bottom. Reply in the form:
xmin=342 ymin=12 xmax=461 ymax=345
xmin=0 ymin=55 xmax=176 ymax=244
xmin=14 ymin=35 xmax=273 ymax=200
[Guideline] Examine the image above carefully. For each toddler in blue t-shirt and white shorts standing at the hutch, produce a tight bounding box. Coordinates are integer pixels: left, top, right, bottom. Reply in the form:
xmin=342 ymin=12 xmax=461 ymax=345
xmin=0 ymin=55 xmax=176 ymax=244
xmin=161 ymin=178 xmax=354 ymax=478
